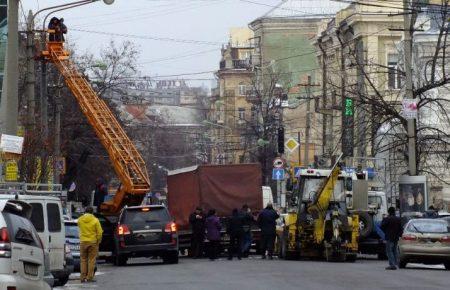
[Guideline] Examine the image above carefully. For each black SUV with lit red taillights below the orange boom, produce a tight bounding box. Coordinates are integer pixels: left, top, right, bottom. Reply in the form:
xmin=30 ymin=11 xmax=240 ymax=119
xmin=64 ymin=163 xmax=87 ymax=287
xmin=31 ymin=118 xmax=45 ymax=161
xmin=114 ymin=205 xmax=178 ymax=266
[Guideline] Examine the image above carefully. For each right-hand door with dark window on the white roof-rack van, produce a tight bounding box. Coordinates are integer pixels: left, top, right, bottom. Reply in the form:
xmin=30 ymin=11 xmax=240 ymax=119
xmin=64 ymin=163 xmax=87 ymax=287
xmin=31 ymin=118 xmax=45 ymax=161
xmin=45 ymin=200 xmax=65 ymax=271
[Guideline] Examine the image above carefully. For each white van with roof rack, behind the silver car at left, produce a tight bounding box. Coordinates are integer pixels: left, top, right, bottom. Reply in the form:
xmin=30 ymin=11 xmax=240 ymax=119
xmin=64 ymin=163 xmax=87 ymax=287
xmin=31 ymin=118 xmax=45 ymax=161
xmin=0 ymin=194 xmax=70 ymax=286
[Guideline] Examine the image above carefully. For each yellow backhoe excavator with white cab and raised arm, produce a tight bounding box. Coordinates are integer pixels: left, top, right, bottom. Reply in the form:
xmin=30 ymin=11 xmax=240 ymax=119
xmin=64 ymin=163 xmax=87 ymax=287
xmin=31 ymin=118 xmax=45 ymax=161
xmin=277 ymin=155 xmax=359 ymax=262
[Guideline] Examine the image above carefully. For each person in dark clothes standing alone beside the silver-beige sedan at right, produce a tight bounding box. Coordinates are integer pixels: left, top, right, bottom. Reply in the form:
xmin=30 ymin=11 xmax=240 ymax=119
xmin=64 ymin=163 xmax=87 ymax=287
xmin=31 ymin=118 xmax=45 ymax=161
xmin=381 ymin=207 xmax=403 ymax=270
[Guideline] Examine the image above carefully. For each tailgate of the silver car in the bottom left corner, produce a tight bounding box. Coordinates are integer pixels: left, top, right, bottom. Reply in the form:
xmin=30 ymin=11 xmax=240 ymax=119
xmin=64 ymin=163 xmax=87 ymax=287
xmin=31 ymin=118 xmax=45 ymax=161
xmin=4 ymin=213 xmax=45 ymax=289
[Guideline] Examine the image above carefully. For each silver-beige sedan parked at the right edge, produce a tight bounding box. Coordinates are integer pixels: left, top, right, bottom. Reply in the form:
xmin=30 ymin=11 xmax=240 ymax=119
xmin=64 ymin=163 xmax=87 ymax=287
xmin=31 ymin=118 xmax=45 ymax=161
xmin=399 ymin=219 xmax=450 ymax=270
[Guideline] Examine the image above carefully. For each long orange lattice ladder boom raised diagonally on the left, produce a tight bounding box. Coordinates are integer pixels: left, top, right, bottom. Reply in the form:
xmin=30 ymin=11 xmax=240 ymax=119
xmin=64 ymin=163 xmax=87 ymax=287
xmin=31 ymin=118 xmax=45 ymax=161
xmin=43 ymin=42 xmax=150 ymax=214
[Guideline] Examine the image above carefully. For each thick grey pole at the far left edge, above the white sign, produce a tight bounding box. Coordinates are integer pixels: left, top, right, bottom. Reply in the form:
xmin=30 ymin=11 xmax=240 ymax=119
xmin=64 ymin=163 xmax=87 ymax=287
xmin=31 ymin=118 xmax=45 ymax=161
xmin=0 ymin=0 xmax=19 ymax=135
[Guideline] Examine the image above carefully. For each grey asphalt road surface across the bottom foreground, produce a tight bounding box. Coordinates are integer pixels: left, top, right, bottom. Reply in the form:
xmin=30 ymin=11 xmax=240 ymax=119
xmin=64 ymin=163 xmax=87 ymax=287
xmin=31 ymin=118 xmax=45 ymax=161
xmin=55 ymin=257 xmax=450 ymax=290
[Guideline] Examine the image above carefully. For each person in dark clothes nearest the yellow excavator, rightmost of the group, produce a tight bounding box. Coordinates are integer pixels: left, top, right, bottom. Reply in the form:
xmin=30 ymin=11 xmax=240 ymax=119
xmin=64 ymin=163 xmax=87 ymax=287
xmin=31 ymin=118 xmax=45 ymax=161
xmin=258 ymin=203 xmax=280 ymax=260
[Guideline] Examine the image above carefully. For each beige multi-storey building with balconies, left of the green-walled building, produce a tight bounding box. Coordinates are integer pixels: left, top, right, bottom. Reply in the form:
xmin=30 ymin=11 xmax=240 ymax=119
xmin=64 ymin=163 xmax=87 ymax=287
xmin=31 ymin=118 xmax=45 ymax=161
xmin=209 ymin=28 xmax=254 ymax=164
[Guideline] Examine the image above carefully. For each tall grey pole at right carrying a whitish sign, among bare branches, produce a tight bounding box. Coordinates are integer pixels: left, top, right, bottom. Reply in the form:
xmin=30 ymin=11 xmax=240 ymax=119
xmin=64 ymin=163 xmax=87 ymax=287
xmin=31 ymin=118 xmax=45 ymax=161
xmin=403 ymin=0 xmax=417 ymax=176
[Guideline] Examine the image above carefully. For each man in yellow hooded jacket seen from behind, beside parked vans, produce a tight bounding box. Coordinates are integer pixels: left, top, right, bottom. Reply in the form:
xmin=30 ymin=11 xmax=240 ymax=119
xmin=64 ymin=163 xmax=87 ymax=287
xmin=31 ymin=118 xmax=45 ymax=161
xmin=78 ymin=207 xmax=103 ymax=283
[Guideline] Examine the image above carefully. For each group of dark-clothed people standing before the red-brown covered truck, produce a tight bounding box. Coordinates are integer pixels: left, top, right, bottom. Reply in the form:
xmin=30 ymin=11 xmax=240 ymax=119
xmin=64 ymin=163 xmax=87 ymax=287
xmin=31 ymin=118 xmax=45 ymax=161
xmin=189 ymin=204 xmax=279 ymax=260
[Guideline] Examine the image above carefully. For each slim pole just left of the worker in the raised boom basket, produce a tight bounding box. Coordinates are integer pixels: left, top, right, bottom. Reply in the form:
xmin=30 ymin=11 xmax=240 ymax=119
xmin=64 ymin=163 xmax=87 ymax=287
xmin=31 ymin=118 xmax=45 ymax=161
xmin=26 ymin=10 xmax=36 ymax=131
